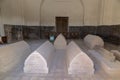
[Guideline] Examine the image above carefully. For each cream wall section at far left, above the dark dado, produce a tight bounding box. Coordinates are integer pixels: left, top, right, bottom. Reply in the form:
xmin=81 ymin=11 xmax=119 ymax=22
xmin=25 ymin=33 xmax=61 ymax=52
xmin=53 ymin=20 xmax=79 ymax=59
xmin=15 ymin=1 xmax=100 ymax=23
xmin=1 ymin=0 xmax=24 ymax=25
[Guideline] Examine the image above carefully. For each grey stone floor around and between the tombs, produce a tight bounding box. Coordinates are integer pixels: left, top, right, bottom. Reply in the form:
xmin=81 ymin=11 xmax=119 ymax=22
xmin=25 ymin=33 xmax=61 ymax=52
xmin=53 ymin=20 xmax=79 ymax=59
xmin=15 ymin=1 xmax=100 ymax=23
xmin=0 ymin=40 xmax=120 ymax=80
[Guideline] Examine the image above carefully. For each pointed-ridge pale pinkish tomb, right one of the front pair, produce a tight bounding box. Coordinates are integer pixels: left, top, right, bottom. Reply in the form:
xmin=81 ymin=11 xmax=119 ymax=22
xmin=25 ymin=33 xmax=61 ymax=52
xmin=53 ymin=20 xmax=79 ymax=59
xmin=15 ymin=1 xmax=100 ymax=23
xmin=67 ymin=41 xmax=94 ymax=75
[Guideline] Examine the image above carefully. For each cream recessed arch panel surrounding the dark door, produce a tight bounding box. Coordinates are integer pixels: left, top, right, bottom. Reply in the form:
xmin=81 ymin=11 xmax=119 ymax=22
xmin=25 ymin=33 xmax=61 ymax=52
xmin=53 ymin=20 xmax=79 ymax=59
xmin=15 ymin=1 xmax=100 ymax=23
xmin=40 ymin=0 xmax=84 ymax=26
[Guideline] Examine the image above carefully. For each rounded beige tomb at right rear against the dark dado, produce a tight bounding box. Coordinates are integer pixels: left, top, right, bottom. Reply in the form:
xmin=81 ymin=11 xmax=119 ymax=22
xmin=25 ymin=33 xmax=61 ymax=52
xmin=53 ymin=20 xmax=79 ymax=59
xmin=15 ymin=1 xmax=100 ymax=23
xmin=84 ymin=34 xmax=104 ymax=49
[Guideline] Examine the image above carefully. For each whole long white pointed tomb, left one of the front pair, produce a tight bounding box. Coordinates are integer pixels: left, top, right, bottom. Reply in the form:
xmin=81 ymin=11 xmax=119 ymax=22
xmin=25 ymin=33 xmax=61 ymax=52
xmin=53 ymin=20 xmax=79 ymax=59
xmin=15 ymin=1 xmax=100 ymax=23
xmin=24 ymin=41 xmax=55 ymax=73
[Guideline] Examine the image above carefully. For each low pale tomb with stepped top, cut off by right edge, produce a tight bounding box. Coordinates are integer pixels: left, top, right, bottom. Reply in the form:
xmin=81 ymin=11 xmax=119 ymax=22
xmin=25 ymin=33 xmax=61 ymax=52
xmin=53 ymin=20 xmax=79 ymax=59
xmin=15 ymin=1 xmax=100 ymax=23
xmin=89 ymin=48 xmax=120 ymax=76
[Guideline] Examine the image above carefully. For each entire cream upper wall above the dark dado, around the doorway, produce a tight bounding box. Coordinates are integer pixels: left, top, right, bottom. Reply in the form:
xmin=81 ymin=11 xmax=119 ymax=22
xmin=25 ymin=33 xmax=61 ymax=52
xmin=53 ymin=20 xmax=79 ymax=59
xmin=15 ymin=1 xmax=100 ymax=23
xmin=0 ymin=0 xmax=120 ymax=35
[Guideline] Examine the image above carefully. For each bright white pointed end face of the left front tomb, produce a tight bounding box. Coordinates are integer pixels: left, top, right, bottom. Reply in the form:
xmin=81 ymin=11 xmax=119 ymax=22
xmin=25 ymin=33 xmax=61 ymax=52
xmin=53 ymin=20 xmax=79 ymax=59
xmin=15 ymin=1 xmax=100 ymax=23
xmin=24 ymin=51 xmax=48 ymax=73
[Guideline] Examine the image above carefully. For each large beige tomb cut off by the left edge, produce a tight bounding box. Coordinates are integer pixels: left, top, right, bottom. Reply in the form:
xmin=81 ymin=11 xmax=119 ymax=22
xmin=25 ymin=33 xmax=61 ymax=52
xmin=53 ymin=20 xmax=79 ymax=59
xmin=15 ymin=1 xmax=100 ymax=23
xmin=0 ymin=41 xmax=31 ymax=72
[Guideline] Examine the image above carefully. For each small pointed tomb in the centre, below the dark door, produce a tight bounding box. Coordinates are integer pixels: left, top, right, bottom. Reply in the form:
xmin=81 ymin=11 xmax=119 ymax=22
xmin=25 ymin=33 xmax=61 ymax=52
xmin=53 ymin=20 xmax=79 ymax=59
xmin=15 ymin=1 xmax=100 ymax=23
xmin=54 ymin=34 xmax=67 ymax=49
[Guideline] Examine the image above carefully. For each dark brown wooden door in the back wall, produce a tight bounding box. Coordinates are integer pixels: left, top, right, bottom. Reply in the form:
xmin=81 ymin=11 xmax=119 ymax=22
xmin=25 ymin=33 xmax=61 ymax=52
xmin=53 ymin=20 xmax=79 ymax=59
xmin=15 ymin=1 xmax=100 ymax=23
xmin=56 ymin=17 xmax=68 ymax=33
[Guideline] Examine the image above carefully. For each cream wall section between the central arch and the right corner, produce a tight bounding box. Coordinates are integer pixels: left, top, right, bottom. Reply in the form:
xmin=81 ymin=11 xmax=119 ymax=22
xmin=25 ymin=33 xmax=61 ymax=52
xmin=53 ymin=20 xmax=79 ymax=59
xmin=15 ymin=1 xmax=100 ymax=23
xmin=83 ymin=0 xmax=100 ymax=25
